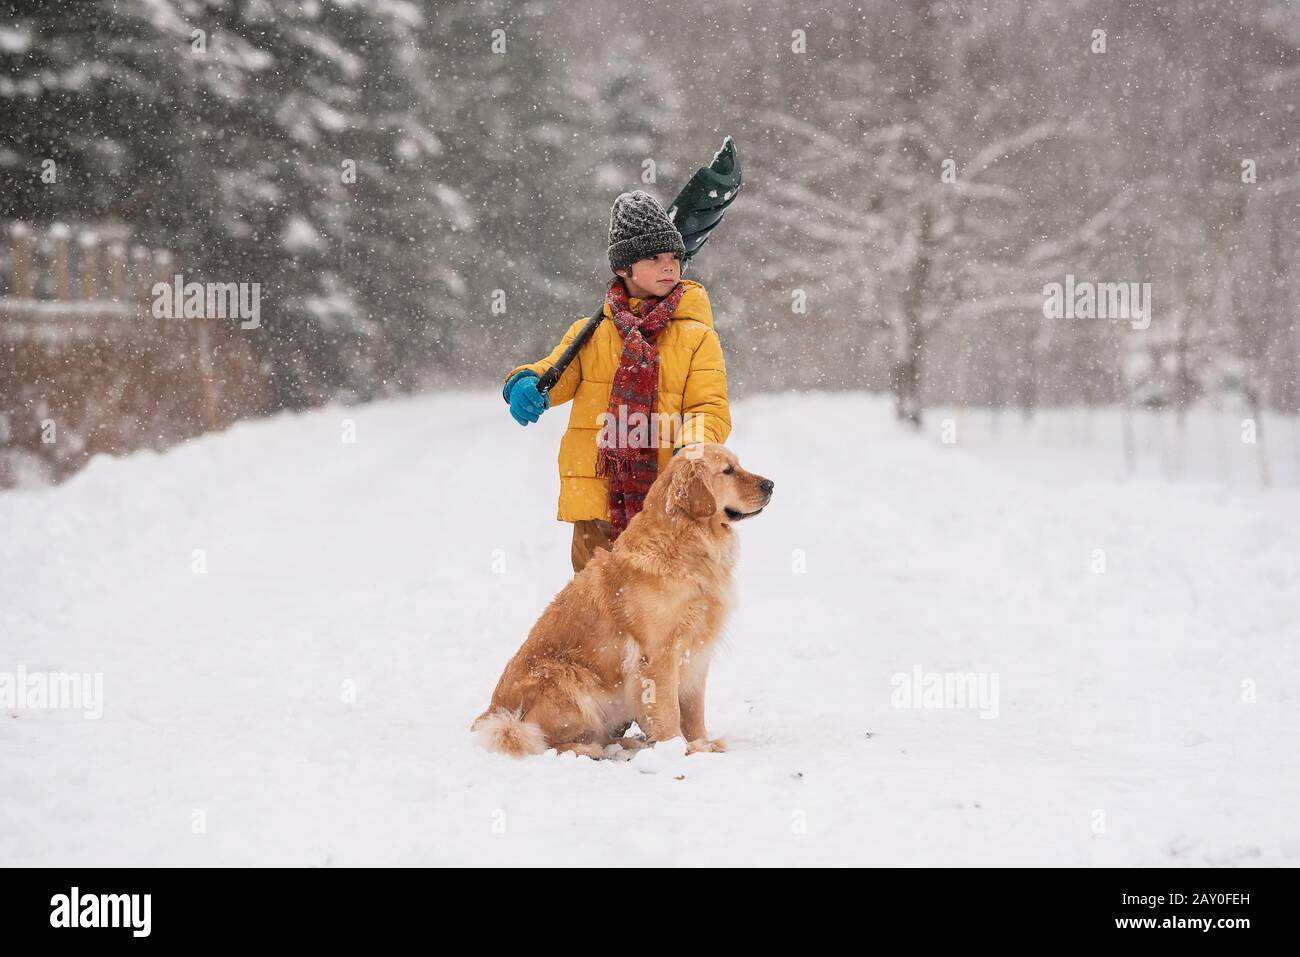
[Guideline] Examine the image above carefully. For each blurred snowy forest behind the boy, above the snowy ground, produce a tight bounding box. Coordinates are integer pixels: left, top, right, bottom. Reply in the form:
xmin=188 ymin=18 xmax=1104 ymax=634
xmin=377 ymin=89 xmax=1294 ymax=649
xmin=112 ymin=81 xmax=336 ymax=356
xmin=0 ymin=0 xmax=1300 ymax=484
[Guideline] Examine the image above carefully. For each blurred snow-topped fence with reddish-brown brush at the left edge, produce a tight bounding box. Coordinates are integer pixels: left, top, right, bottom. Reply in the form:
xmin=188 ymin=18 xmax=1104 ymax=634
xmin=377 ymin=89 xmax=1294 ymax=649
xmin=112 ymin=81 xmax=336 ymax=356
xmin=0 ymin=222 xmax=269 ymax=488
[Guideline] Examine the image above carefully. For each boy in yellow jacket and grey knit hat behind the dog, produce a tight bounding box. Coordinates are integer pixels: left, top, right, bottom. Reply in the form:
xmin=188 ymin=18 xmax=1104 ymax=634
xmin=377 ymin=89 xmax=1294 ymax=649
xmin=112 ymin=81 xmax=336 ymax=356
xmin=502 ymin=190 xmax=731 ymax=573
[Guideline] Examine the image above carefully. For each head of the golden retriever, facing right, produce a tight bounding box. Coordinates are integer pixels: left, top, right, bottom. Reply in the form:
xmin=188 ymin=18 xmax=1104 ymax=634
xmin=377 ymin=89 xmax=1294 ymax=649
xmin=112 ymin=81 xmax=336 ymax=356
xmin=663 ymin=442 xmax=774 ymax=525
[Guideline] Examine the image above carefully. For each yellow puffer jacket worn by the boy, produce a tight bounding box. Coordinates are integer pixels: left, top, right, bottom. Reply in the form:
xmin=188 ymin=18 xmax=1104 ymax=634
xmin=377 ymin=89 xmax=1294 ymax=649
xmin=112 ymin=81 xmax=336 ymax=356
xmin=504 ymin=280 xmax=731 ymax=521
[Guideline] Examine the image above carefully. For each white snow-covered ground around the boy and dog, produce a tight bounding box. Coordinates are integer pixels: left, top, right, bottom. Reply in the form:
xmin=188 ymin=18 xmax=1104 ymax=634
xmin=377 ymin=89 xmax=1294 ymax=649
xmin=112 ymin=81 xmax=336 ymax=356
xmin=0 ymin=390 xmax=1300 ymax=866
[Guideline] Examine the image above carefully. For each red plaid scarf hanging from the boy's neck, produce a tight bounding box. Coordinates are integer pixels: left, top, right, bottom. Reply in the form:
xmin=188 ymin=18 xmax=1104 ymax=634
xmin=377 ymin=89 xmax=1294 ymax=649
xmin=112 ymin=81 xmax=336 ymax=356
xmin=595 ymin=277 xmax=686 ymax=542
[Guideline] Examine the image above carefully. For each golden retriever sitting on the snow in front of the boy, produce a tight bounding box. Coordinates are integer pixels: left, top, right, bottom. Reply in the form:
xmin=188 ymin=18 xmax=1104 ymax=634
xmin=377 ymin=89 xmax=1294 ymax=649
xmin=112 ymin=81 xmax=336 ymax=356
xmin=471 ymin=442 xmax=772 ymax=758
